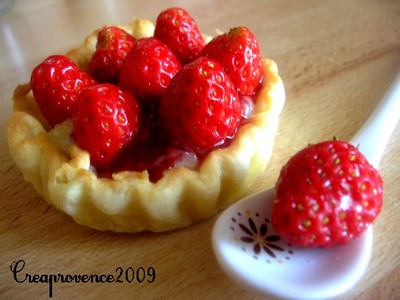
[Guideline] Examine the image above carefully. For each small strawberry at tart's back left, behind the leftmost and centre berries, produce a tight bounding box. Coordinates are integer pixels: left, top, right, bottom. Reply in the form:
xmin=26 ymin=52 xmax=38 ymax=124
xmin=88 ymin=26 xmax=136 ymax=84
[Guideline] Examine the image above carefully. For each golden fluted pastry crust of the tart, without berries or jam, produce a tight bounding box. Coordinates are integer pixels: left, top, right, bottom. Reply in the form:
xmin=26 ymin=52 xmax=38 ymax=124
xmin=8 ymin=19 xmax=285 ymax=232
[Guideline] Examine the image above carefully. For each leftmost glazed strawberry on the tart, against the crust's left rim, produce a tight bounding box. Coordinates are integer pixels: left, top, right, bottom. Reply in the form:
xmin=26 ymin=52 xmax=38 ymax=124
xmin=31 ymin=55 xmax=95 ymax=127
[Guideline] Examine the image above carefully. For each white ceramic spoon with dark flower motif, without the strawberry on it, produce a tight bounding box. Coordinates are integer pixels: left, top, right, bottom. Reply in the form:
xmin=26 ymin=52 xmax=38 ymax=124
xmin=212 ymin=74 xmax=400 ymax=299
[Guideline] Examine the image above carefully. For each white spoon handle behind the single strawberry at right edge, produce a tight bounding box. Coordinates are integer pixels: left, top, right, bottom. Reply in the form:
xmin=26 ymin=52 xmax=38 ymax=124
xmin=350 ymin=73 xmax=400 ymax=168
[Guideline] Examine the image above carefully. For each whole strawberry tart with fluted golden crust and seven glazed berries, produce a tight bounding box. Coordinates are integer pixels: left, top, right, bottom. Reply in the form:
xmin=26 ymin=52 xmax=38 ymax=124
xmin=8 ymin=8 xmax=285 ymax=232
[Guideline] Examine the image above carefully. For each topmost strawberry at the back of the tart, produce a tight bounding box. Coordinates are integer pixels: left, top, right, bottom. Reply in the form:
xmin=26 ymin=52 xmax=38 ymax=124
xmin=154 ymin=7 xmax=205 ymax=64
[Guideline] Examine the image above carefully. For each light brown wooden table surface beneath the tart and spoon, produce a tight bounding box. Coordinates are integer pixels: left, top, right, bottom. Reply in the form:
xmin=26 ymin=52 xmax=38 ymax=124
xmin=0 ymin=0 xmax=400 ymax=299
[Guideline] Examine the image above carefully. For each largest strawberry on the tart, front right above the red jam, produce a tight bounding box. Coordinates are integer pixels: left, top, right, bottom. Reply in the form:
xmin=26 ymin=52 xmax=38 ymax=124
xmin=160 ymin=57 xmax=241 ymax=152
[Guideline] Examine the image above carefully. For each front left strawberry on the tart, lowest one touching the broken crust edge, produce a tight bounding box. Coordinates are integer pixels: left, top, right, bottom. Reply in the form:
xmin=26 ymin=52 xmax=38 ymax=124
xmin=73 ymin=84 xmax=140 ymax=169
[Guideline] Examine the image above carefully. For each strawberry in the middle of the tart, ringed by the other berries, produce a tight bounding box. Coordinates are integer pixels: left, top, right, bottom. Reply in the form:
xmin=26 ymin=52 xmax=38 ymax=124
xmin=119 ymin=37 xmax=181 ymax=99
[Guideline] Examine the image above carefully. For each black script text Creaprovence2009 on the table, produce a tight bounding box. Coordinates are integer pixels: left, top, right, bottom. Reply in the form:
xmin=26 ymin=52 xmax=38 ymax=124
xmin=10 ymin=259 xmax=156 ymax=297
